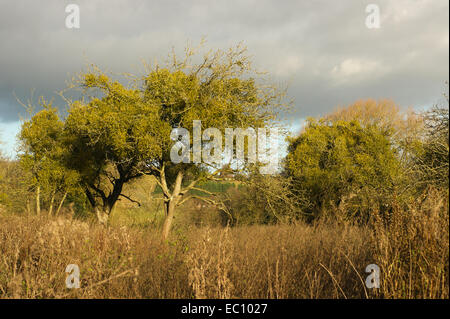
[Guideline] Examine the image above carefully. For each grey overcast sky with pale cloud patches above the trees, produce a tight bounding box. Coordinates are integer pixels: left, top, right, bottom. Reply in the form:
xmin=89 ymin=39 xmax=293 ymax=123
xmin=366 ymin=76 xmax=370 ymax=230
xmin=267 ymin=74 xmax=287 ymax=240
xmin=0 ymin=0 xmax=449 ymax=158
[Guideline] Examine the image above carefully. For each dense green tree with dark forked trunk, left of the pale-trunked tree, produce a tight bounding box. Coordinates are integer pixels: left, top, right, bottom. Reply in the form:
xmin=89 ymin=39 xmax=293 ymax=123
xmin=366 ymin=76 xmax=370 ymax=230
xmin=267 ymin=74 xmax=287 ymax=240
xmin=64 ymin=73 xmax=163 ymax=224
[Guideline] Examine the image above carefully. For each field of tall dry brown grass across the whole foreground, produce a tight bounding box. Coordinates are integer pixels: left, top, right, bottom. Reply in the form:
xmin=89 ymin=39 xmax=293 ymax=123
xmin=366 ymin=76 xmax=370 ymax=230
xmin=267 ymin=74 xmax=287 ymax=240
xmin=0 ymin=189 xmax=449 ymax=298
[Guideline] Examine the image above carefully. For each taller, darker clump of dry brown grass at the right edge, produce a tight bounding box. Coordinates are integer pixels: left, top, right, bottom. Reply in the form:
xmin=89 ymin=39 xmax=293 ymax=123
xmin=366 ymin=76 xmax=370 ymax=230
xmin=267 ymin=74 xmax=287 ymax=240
xmin=371 ymin=191 xmax=449 ymax=298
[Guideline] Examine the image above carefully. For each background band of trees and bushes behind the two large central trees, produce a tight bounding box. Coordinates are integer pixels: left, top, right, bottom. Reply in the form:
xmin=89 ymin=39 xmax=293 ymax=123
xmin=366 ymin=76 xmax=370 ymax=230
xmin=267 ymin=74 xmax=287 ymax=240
xmin=0 ymin=100 xmax=449 ymax=225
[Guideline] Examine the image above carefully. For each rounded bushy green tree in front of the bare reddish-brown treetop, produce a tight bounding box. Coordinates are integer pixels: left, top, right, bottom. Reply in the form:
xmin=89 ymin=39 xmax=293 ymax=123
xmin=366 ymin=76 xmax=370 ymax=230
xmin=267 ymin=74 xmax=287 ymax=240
xmin=286 ymin=119 xmax=400 ymax=218
